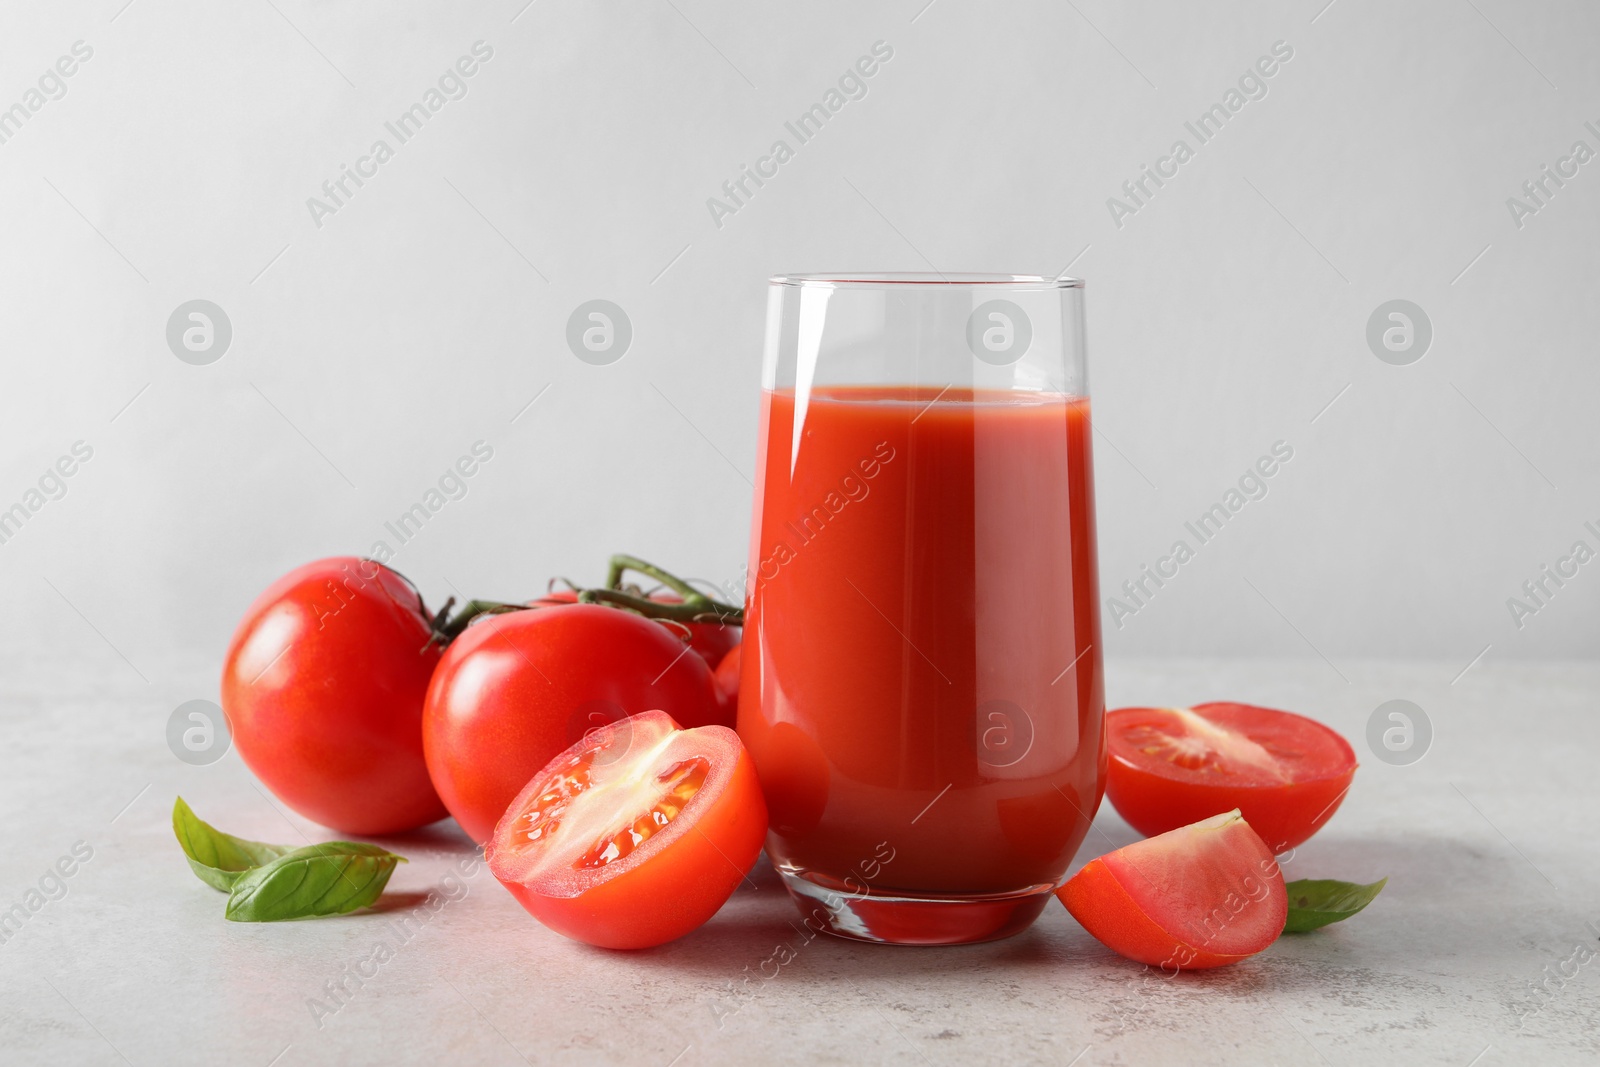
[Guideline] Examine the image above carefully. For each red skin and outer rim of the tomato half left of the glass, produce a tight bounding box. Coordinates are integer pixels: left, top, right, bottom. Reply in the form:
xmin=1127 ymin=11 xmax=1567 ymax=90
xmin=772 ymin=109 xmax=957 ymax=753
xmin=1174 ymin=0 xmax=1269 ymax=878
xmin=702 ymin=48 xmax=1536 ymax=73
xmin=486 ymin=712 xmax=766 ymax=949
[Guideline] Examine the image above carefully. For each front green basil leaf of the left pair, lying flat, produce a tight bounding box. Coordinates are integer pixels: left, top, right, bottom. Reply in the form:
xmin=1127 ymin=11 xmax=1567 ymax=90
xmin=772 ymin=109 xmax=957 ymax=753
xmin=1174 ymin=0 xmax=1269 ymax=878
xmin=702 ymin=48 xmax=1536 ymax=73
xmin=227 ymin=841 xmax=406 ymax=923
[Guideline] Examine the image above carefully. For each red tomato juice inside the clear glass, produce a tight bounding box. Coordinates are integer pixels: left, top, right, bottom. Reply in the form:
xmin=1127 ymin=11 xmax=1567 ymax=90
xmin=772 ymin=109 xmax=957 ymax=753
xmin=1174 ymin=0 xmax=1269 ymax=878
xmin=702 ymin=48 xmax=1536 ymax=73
xmin=739 ymin=387 xmax=1106 ymax=894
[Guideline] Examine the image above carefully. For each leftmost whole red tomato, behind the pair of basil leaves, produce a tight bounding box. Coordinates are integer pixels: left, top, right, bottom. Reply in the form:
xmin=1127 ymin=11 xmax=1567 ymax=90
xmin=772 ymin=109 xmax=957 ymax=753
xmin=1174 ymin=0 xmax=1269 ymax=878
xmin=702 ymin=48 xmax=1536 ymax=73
xmin=222 ymin=557 xmax=448 ymax=835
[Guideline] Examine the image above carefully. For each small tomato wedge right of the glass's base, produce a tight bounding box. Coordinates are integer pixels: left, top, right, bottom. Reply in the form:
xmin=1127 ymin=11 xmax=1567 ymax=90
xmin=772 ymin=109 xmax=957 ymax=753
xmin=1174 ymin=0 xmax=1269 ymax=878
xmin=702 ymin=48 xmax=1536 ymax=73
xmin=1056 ymin=811 xmax=1290 ymax=974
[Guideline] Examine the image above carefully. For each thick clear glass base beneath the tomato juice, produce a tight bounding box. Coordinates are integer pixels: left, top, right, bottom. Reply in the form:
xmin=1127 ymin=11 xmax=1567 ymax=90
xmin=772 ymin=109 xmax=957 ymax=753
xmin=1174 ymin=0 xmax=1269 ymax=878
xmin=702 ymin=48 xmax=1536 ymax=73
xmin=778 ymin=865 xmax=1054 ymax=945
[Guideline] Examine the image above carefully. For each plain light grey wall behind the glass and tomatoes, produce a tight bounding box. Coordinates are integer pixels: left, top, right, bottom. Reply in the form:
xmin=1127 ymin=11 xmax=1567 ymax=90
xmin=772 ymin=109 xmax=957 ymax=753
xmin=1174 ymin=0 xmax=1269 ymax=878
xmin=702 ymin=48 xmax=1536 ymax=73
xmin=0 ymin=0 xmax=1600 ymax=684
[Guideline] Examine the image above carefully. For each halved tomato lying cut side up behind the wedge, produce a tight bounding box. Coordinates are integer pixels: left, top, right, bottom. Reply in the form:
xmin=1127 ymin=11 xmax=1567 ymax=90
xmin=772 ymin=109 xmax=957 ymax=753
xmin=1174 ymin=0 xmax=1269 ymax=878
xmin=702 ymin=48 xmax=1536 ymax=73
xmin=1106 ymin=704 xmax=1355 ymax=853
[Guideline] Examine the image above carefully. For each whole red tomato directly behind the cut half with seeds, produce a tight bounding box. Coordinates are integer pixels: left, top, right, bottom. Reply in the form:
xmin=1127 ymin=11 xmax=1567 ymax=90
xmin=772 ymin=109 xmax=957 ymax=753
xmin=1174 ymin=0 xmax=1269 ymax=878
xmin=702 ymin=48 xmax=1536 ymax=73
xmin=422 ymin=605 xmax=722 ymax=841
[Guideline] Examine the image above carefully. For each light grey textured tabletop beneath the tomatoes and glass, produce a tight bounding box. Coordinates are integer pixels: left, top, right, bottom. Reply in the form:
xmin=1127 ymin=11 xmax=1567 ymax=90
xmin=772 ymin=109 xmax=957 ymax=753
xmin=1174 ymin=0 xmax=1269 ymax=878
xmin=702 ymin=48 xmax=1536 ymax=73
xmin=0 ymin=649 xmax=1600 ymax=1067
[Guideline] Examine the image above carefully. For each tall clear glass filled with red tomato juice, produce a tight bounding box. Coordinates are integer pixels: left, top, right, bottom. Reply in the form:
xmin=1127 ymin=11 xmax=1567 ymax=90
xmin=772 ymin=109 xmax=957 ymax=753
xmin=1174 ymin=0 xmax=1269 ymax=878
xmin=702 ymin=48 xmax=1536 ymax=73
xmin=739 ymin=274 xmax=1106 ymax=944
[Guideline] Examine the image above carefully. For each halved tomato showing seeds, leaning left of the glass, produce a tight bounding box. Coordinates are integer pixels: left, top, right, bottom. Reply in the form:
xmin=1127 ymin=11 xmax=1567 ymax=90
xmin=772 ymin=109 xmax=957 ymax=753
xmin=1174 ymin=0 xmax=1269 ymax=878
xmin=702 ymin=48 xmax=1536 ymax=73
xmin=485 ymin=712 xmax=766 ymax=949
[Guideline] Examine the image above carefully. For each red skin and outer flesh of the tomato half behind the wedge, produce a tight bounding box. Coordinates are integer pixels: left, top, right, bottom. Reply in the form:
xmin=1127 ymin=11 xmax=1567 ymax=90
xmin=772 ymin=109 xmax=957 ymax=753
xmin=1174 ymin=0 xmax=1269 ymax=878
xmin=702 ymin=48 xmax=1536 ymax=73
xmin=1106 ymin=702 xmax=1357 ymax=853
